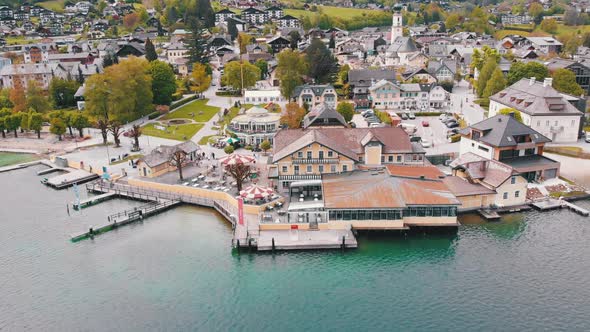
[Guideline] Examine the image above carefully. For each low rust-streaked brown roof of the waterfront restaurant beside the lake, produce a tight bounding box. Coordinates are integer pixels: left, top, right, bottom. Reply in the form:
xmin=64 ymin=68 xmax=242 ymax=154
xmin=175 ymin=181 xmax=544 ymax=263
xmin=322 ymin=170 xmax=460 ymax=209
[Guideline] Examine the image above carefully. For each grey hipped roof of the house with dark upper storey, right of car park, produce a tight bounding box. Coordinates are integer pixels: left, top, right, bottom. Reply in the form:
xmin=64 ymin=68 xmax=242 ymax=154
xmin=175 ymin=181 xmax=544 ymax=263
xmin=461 ymin=114 xmax=551 ymax=147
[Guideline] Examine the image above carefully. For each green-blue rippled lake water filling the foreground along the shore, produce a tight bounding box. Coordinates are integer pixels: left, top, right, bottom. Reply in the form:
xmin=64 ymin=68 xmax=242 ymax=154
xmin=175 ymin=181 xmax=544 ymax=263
xmin=0 ymin=168 xmax=590 ymax=331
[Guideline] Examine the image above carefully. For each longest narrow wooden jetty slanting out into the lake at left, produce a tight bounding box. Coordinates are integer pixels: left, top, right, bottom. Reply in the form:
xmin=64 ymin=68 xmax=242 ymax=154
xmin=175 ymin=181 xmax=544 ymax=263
xmin=71 ymin=200 xmax=180 ymax=242
